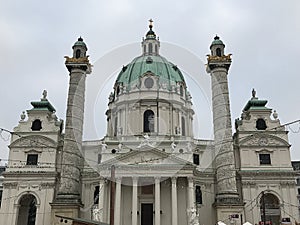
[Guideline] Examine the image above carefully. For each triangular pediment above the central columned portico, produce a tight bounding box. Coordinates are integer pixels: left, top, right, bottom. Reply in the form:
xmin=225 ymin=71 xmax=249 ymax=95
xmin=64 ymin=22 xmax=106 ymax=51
xmin=103 ymin=149 xmax=192 ymax=166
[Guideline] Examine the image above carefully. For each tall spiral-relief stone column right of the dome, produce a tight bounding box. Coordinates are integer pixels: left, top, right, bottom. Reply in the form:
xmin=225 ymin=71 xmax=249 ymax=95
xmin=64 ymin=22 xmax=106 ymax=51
xmin=207 ymin=36 xmax=242 ymax=221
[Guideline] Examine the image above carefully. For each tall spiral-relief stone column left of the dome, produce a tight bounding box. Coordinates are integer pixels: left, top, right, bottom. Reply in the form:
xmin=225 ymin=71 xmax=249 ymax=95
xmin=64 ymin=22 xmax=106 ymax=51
xmin=52 ymin=37 xmax=92 ymax=217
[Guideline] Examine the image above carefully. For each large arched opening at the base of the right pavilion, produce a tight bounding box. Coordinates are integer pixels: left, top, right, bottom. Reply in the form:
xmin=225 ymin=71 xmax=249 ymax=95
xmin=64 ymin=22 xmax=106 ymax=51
xmin=260 ymin=193 xmax=281 ymax=224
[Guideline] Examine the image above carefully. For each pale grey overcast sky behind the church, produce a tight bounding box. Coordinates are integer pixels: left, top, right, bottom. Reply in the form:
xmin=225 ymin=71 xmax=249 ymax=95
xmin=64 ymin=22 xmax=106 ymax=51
xmin=0 ymin=0 xmax=300 ymax=164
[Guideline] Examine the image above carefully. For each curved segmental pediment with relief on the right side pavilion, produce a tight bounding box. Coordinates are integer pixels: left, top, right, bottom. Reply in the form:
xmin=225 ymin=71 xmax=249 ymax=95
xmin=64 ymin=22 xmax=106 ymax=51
xmin=240 ymin=135 xmax=290 ymax=147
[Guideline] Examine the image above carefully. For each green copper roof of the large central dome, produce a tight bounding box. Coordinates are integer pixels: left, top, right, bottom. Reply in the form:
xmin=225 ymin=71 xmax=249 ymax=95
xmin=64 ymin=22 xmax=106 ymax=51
xmin=116 ymin=55 xmax=184 ymax=86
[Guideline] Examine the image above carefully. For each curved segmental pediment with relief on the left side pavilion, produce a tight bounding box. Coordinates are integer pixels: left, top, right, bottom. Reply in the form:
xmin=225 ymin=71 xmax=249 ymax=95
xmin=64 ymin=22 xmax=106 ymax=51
xmin=9 ymin=135 xmax=57 ymax=148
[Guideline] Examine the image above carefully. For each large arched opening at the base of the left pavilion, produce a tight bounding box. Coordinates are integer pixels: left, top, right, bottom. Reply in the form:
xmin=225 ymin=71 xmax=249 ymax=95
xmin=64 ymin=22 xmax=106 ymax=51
xmin=17 ymin=194 xmax=36 ymax=225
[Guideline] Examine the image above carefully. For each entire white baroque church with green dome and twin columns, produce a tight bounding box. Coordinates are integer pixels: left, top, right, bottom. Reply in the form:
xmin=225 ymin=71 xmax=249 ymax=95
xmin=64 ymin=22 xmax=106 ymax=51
xmin=0 ymin=22 xmax=299 ymax=225
